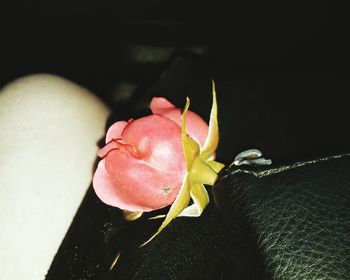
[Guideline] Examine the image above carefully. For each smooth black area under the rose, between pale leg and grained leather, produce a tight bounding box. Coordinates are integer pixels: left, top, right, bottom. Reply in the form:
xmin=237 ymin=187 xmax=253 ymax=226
xmin=46 ymin=184 xmax=237 ymax=280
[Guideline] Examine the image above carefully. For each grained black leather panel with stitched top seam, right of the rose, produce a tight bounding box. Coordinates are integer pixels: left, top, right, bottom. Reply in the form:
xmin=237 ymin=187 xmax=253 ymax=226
xmin=214 ymin=155 xmax=350 ymax=280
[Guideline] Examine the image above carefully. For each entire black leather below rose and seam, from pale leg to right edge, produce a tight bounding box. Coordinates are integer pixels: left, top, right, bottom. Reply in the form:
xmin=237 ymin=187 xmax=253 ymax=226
xmin=47 ymin=156 xmax=350 ymax=280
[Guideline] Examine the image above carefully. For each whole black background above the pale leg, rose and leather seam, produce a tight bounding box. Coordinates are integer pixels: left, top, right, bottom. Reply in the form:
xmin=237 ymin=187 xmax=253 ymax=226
xmin=0 ymin=0 xmax=350 ymax=163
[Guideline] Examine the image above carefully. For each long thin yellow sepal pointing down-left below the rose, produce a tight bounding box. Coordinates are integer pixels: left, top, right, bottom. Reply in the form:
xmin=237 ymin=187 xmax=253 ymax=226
xmin=141 ymin=175 xmax=190 ymax=247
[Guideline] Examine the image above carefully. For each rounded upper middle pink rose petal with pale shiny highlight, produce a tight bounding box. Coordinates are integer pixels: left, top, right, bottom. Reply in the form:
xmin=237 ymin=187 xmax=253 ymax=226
xmin=122 ymin=115 xmax=186 ymax=174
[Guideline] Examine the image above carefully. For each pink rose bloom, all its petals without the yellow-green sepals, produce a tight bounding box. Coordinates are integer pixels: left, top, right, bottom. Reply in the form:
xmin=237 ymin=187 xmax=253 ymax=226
xmin=93 ymin=97 xmax=208 ymax=212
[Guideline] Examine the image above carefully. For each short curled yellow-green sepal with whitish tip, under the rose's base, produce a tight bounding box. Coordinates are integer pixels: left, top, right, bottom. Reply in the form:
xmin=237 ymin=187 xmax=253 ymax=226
xmin=179 ymin=183 xmax=209 ymax=217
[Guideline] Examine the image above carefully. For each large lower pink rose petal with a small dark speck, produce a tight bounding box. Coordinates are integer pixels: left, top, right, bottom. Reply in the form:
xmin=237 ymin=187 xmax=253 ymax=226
xmin=102 ymin=149 xmax=184 ymax=211
